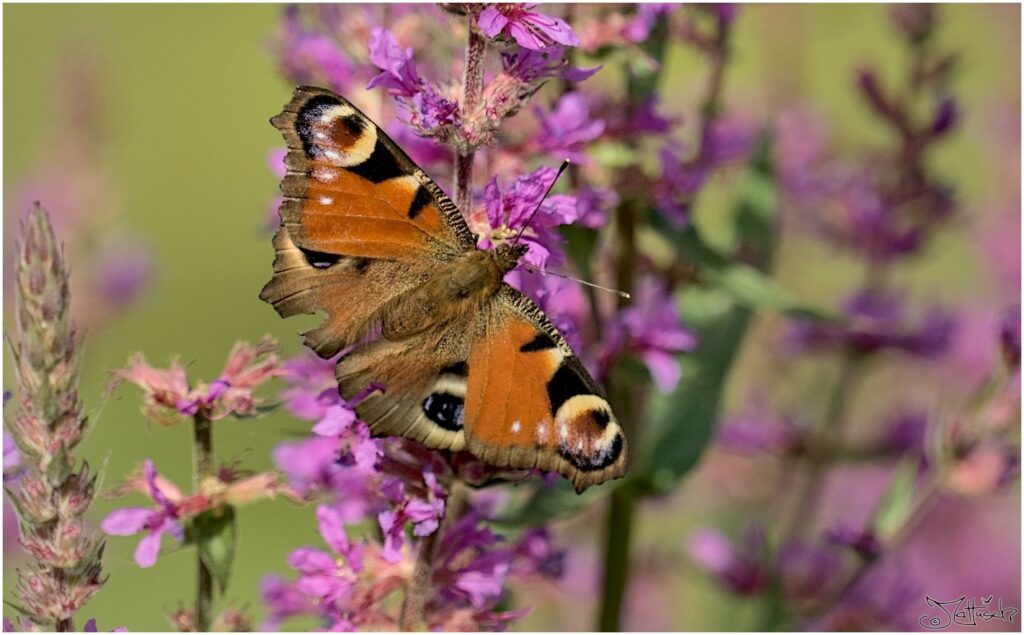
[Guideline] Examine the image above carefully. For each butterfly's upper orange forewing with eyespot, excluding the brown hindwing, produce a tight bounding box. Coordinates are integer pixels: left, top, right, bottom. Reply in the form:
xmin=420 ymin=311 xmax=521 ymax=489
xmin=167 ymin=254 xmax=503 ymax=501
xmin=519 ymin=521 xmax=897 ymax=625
xmin=271 ymin=88 xmax=468 ymax=260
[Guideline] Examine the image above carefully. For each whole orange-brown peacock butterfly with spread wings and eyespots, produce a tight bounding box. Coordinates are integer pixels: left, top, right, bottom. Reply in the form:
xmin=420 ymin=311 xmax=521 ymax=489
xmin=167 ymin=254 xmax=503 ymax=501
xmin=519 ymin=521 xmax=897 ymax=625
xmin=260 ymin=87 xmax=627 ymax=491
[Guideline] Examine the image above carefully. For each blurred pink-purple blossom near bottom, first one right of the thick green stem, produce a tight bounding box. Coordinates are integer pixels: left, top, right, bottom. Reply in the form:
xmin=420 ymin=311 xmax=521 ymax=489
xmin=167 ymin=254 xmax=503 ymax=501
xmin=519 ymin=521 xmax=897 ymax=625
xmin=688 ymin=530 xmax=767 ymax=595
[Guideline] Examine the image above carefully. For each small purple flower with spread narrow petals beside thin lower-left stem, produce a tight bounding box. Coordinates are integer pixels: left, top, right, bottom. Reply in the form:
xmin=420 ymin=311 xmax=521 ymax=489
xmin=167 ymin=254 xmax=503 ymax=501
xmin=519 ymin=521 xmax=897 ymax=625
xmin=100 ymin=459 xmax=184 ymax=568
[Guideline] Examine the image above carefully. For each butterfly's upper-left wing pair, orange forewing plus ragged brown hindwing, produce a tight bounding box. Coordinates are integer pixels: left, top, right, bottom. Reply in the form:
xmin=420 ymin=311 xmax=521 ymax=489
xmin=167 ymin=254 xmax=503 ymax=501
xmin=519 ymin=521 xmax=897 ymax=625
xmin=260 ymin=87 xmax=475 ymax=356
